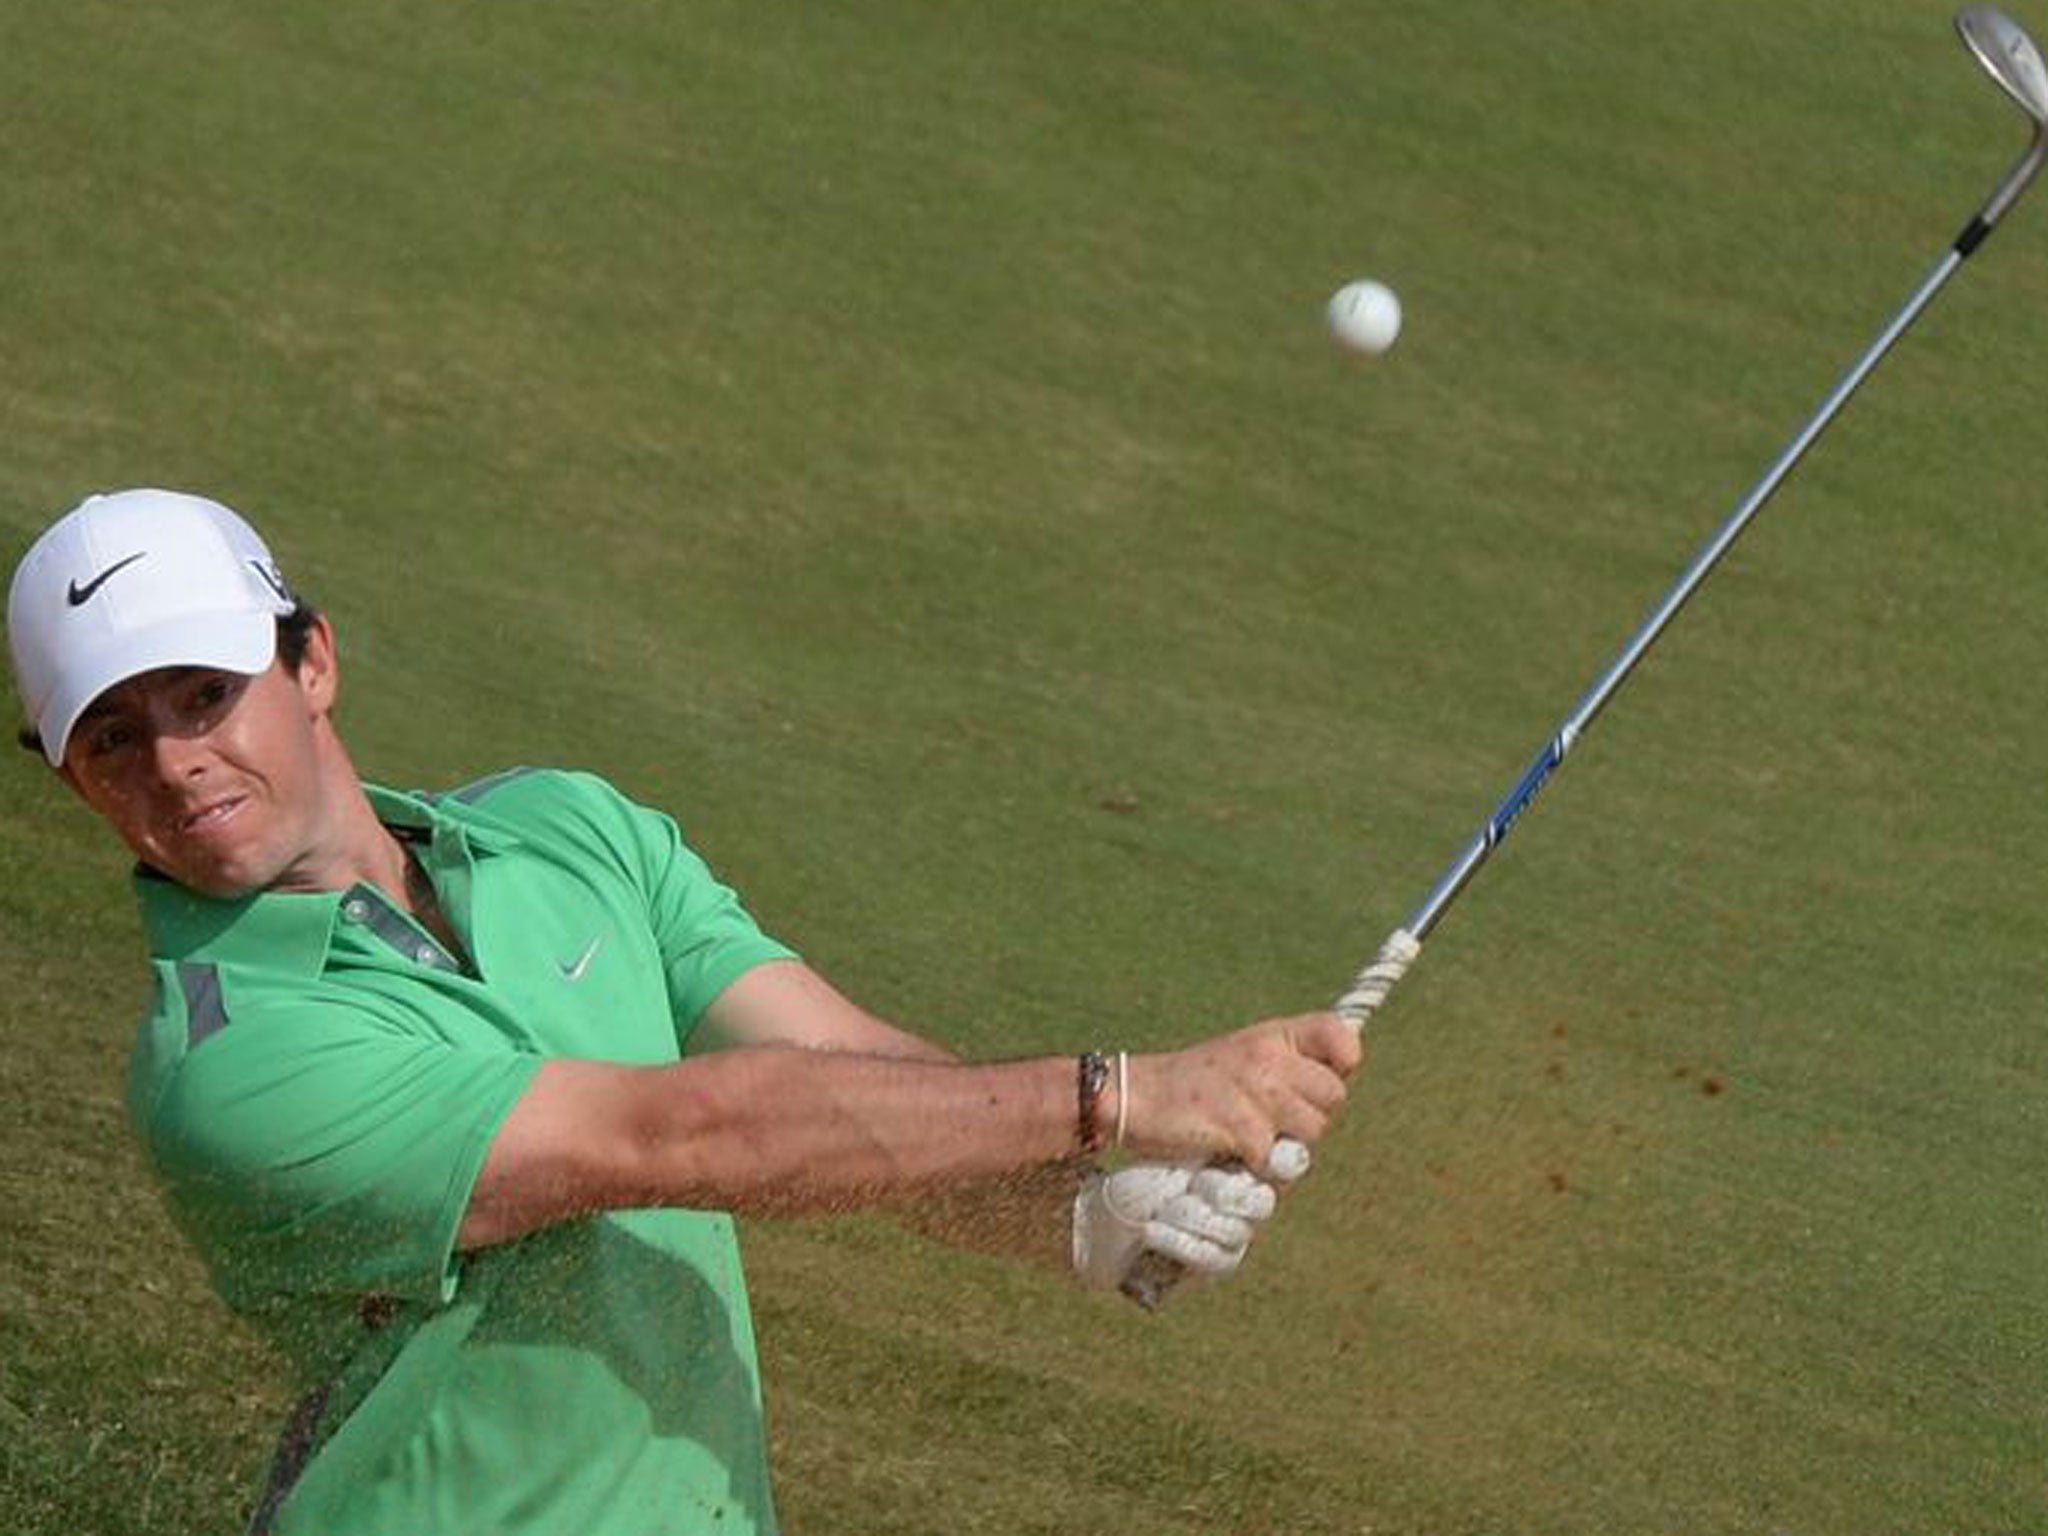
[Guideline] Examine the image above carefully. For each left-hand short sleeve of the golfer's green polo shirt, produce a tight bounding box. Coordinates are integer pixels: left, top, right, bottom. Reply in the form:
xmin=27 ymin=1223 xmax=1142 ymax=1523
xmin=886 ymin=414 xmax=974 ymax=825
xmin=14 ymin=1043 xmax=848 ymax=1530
xmin=135 ymin=981 xmax=541 ymax=1305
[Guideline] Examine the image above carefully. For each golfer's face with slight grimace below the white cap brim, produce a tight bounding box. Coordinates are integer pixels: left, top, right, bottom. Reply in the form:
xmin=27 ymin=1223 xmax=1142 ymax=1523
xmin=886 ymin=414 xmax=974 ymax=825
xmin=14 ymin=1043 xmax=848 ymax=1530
xmin=59 ymin=625 xmax=334 ymax=897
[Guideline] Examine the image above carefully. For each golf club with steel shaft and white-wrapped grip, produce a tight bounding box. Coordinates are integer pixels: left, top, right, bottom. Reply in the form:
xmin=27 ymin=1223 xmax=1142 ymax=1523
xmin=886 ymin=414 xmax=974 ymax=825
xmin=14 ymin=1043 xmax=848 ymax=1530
xmin=1122 ymin=4 xmax=2048 ymax=1309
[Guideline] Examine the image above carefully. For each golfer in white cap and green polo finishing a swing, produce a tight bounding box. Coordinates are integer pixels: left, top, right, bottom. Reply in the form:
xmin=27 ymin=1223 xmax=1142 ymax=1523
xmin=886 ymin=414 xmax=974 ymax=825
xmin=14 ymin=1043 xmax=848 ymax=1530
xmin=8 ymin=489 xmax=1358 ymax=1536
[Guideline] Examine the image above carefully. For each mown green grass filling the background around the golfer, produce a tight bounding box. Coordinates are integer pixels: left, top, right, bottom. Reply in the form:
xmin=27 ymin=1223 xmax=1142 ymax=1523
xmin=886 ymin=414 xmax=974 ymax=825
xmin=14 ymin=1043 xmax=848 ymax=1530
xmin=0 ymin=0 xmax=2048 ymax=1536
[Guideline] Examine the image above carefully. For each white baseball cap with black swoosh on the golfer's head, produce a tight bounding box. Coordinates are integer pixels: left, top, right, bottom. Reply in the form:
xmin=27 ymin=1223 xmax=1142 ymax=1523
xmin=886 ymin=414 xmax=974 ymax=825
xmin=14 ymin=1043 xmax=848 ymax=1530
xmin=6 ymin=489 xmax=293 ymax=766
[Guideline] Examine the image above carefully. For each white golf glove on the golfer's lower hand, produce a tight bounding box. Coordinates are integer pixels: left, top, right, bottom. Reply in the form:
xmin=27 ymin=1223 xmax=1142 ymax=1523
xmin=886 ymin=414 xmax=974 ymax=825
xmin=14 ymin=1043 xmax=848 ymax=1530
xmin=1073 ymin=1163 xmax=1276 ymax=1290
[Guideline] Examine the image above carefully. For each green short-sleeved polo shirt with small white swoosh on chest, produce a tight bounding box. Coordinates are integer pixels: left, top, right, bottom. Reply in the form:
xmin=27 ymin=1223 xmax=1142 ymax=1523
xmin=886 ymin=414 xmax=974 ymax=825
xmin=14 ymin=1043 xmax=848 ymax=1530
xmin=129 ymin=770 xmax=791 ymax=1536
